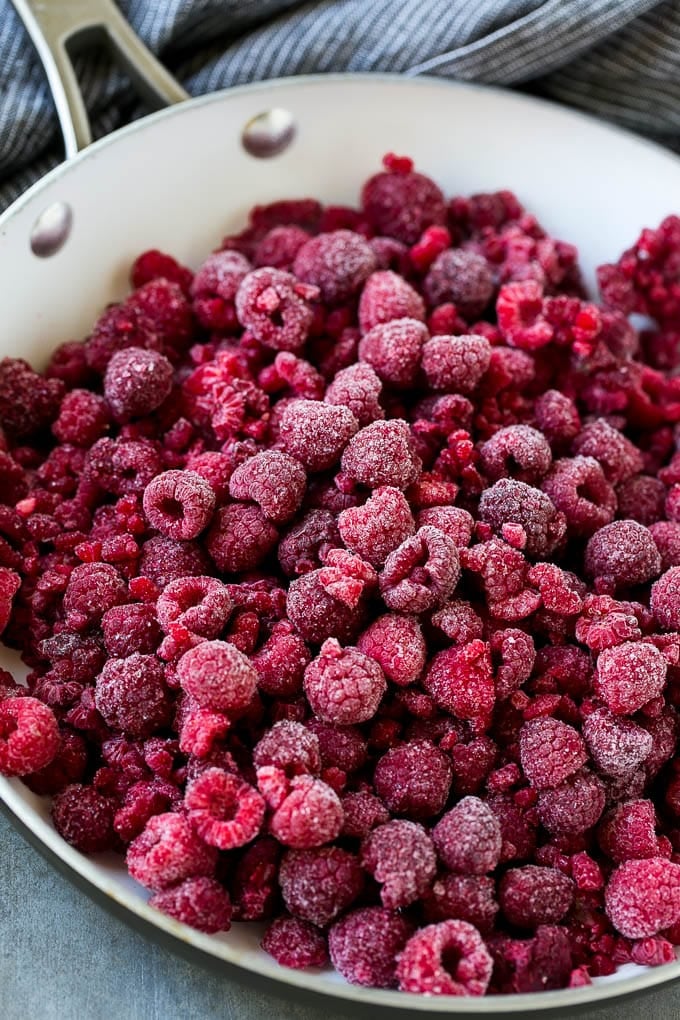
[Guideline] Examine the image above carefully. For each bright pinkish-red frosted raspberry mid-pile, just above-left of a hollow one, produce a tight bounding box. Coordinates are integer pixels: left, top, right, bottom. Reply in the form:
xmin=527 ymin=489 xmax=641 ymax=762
xmin=337 ymin=486 xmax=415 ymax=567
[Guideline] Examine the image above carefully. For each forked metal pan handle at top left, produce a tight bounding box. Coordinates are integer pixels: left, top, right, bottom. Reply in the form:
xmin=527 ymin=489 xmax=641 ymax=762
xmin=12 ymin=0 xmax=189 ymax=159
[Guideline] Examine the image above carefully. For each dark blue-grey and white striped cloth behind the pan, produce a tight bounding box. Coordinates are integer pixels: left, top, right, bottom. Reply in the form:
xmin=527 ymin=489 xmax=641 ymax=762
xmin=0 ymin=0 xmax=680 ymax=209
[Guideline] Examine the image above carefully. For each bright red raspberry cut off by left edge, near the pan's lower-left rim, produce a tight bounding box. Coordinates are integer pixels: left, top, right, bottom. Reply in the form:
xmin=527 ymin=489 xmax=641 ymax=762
xmin=0 ymin=698 xmax=60 ymax=775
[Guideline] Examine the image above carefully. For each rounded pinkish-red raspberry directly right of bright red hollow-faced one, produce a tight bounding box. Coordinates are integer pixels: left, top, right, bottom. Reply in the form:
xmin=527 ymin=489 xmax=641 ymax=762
xmin=270 ymin=775 xmax=343 ymax=850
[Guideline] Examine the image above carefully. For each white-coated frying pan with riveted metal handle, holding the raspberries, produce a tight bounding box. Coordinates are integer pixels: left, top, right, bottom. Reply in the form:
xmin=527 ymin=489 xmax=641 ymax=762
xmin=0 ymin=0 xmax=680 ymax=1015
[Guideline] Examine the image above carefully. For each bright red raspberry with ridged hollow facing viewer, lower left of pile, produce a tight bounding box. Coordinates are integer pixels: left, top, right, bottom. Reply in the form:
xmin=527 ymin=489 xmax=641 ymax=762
xmin=185 ymin=767 xmax=265 ymax=850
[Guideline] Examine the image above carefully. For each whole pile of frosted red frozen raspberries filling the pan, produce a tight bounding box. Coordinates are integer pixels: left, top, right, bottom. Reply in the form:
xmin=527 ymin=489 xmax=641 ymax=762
xmin=0 ymin=156 xmax=680 ymax=996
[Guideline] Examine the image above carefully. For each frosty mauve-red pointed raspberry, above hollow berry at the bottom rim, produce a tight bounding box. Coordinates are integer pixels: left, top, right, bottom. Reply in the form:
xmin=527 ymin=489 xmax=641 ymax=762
xmin=432 ymin=797 xmax=503 ymax=875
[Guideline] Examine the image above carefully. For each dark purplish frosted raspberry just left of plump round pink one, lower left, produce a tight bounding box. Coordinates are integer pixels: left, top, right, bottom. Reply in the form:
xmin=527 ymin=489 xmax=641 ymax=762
xmin=95 ymin=652 xmax=171 ymax=736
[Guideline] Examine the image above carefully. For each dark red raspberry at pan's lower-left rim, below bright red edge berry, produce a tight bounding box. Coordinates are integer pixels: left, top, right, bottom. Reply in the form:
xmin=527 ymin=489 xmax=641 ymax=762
xmin=51 ymin=783 xmax=117 ymax=856
